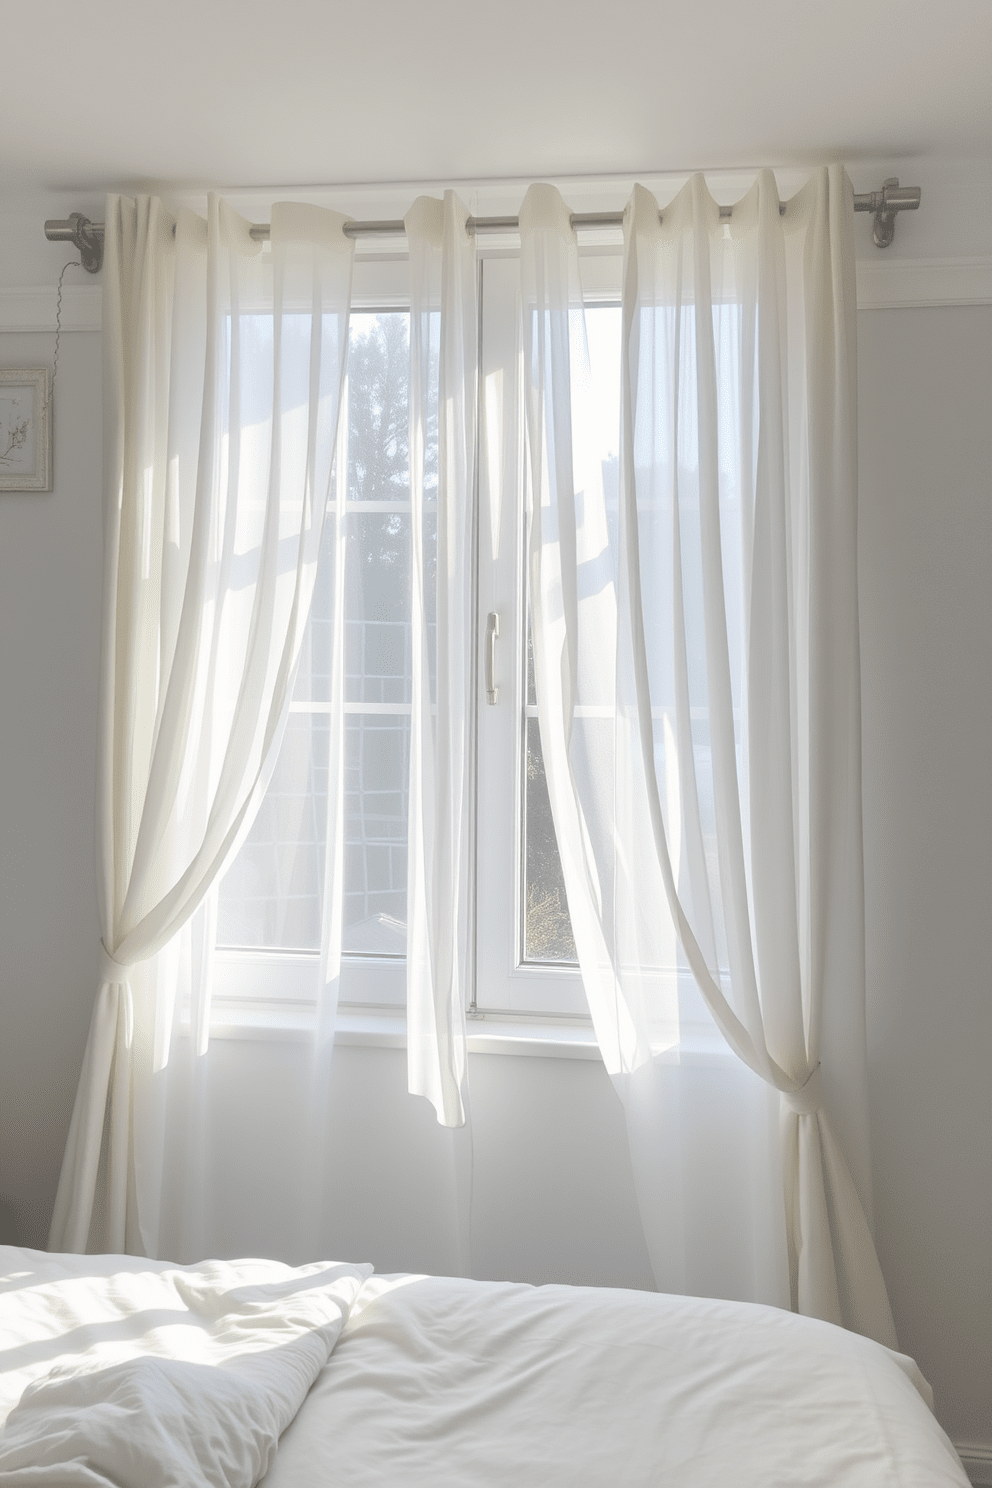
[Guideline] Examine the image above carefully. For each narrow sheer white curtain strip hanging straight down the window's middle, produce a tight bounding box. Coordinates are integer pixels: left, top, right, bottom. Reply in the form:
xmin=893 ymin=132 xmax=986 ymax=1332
xmin=406 ymin=192 xmax=479 ymax=1126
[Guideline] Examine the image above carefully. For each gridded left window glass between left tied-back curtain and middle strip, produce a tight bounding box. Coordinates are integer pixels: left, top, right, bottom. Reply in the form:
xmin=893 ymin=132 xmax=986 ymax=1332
xmin=217 ymin=311 xmax=416 ymax=955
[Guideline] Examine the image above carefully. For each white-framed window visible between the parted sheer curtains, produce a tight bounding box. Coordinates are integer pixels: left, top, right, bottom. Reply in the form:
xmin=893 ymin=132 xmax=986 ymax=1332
xmin=214 ymin=253 xmax=620 ymax=1035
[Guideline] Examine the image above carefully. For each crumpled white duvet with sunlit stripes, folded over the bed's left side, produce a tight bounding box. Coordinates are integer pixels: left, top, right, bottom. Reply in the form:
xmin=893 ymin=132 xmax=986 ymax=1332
xmin=0 ymin=1245 xmax=372 ymax=1488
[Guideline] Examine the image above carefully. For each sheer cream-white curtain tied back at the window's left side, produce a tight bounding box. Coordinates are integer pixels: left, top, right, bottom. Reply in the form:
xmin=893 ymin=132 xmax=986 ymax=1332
xmin=49 ymin=188 xmax=352 ymax=1254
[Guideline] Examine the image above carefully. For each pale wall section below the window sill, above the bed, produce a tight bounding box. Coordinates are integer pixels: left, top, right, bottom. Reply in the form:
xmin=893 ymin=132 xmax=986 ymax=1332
xmin=162 ymin=1039 xmax=653 ymax=1289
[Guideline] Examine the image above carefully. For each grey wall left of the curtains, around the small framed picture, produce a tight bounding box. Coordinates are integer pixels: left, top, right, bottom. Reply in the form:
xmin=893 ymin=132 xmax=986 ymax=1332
xmin=0 ymin=316 xmax=103 ymax=1244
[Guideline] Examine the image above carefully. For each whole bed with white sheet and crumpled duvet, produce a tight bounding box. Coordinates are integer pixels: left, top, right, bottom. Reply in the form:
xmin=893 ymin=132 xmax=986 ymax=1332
xmin=0 ymin=1247 xmax=967 ymax=1488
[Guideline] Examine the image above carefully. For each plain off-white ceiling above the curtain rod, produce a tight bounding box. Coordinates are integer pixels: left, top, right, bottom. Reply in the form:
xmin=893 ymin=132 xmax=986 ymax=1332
xmin=0 ymin=0 xmax=992 ymax=190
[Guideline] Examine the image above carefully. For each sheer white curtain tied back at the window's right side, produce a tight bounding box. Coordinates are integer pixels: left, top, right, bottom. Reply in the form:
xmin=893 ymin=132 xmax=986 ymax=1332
xmin=521 ymin=170 xmax=895 ymax=1344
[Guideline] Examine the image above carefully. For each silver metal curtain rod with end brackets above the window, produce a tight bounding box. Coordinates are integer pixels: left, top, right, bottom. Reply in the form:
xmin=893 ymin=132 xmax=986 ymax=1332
xmin=45 ymin=176 xmax=921 ymax=274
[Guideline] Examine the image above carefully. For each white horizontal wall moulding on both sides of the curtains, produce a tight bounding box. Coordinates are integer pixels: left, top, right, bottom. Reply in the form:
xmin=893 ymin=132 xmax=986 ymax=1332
xmin=0 ymin=256 xmax=992 ymax=335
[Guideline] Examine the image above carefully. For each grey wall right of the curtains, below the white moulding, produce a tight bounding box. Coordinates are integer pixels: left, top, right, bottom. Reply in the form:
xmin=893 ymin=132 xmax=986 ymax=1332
xmin=858 ymin=305 xmax=992 ymax=1442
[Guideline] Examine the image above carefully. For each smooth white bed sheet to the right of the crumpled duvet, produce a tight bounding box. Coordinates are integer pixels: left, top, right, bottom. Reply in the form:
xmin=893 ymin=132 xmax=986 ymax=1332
xmin=263 ymin=1275 xmax=967 ymax=1488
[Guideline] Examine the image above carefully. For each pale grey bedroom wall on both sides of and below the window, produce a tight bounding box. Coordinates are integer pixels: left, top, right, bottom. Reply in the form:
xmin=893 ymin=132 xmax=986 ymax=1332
xmin=0 ymin=183 xmax=992 ymax=1451
